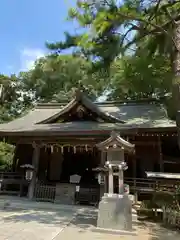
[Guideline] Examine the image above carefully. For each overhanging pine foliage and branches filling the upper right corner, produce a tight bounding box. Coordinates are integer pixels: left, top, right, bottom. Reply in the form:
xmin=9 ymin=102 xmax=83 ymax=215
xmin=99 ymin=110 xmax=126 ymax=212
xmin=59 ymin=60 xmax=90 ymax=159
xmin=44 ymin=0 xmax=180 ymax=118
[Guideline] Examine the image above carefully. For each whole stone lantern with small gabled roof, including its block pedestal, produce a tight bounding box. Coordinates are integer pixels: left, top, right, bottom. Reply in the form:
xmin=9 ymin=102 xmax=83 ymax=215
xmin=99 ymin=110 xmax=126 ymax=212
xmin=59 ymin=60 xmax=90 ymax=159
xmin=97 ymin=132 xmax=134 ymax=231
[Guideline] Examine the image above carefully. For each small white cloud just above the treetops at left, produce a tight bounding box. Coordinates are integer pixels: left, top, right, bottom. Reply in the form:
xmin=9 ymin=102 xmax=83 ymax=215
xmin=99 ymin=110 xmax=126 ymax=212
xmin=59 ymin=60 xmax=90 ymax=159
xmin=21 ymin=48 xmax=45 ymax=71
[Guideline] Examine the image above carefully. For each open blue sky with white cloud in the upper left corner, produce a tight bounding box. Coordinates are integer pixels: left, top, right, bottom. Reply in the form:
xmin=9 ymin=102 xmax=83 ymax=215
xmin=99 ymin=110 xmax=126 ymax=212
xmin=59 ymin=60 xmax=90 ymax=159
xmin=0 ymin=0 xmax=76 ymax=74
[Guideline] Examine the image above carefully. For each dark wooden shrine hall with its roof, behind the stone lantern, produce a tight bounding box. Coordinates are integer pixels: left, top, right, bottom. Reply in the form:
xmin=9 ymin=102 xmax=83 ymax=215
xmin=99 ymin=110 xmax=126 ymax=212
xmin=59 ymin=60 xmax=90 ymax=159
xmin=0 ymin=91 xmax=180 ymax=202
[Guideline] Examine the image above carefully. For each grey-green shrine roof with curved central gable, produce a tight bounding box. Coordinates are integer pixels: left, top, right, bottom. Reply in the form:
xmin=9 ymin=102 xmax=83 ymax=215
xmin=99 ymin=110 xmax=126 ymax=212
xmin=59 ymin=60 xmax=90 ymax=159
xmin=0 ymin=90 xmax=176 ymax=135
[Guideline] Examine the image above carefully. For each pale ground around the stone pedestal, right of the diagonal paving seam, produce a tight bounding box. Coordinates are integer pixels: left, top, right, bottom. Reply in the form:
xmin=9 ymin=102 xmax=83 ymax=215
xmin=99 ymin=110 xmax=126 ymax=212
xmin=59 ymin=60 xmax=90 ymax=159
xmin=54 ymin=210 xmax=180 ymax=240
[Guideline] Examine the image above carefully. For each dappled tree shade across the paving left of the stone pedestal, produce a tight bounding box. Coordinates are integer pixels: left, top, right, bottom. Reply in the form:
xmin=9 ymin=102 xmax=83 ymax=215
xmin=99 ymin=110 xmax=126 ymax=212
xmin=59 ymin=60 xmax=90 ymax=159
xmin=1 ymin=207 xmax=97 ymax=229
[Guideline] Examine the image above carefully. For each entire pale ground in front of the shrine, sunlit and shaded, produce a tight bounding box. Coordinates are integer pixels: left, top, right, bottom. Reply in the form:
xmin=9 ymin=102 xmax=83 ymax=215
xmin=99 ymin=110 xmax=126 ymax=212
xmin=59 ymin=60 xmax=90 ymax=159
xmin=0 ymin=208 xmax=180 ymax=240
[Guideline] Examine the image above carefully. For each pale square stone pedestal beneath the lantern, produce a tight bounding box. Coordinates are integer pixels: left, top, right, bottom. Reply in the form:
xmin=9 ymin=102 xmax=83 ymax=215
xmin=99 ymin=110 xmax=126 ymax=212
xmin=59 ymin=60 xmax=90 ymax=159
xmin=97 ymin=193 xmax=132 ymax=231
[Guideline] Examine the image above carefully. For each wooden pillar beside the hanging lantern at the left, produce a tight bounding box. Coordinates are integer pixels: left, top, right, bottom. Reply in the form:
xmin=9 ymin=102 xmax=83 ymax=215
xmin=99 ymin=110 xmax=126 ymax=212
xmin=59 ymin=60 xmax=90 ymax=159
xmin=28 ymin=144 xmax=40 ymax=200
